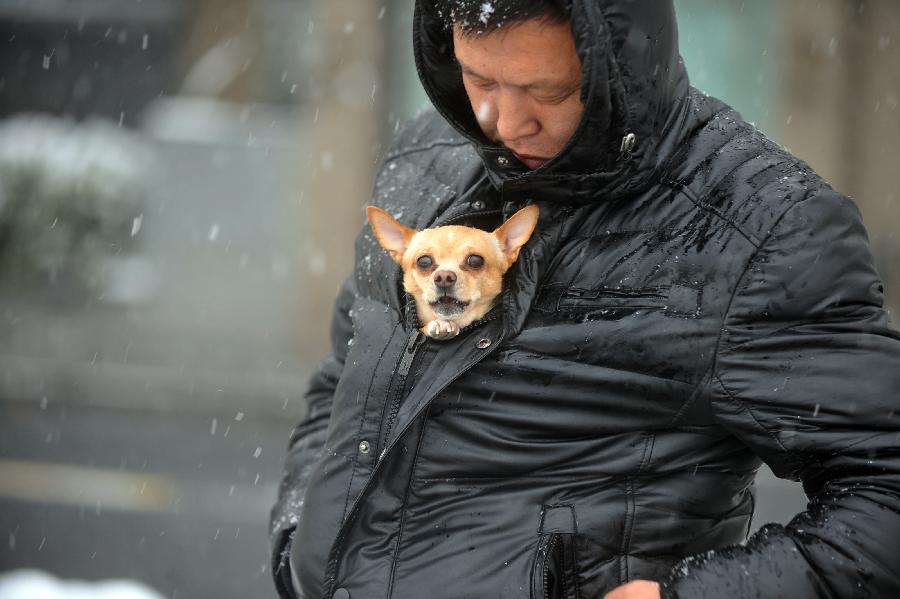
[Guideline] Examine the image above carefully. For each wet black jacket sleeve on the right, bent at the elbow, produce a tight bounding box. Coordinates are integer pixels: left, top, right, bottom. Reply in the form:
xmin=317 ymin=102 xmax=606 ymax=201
xmin=661 ymin=191 xmax=900 ymax=599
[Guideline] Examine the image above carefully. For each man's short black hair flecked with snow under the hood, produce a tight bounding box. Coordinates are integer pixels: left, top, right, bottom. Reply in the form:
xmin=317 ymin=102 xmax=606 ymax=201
xmin=438 ymin=0 xmax=568 ymax=36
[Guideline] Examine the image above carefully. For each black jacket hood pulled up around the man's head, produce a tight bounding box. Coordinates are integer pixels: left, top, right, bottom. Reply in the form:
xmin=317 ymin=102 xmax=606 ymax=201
xmin=413 ymin=0 xmax=689 ymax=201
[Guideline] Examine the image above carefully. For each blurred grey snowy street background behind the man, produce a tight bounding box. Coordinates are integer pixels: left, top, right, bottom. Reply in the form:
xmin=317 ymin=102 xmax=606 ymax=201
xmin=0 ymin=0 xmax=900 ymax=599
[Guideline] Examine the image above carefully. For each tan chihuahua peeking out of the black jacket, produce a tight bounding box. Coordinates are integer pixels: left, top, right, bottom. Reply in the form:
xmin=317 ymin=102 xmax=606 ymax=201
xmin=366 ymin=205 xmax=539 ymax=339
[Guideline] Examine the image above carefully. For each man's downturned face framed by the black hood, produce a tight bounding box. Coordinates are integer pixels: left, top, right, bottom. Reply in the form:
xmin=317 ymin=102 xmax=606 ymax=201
xmin=453 ymin=19 xmax=584 ymax=169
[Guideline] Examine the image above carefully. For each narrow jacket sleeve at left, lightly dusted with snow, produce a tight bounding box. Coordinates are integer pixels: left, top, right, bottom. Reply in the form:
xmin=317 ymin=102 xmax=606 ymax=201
xmin=270 ymin=274 xmax=356 ymax=599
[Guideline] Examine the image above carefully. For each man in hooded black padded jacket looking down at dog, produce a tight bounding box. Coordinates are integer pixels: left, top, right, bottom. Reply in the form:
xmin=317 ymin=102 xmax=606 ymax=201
xmin=273 ymin=0 xmax=900 ymax=599
